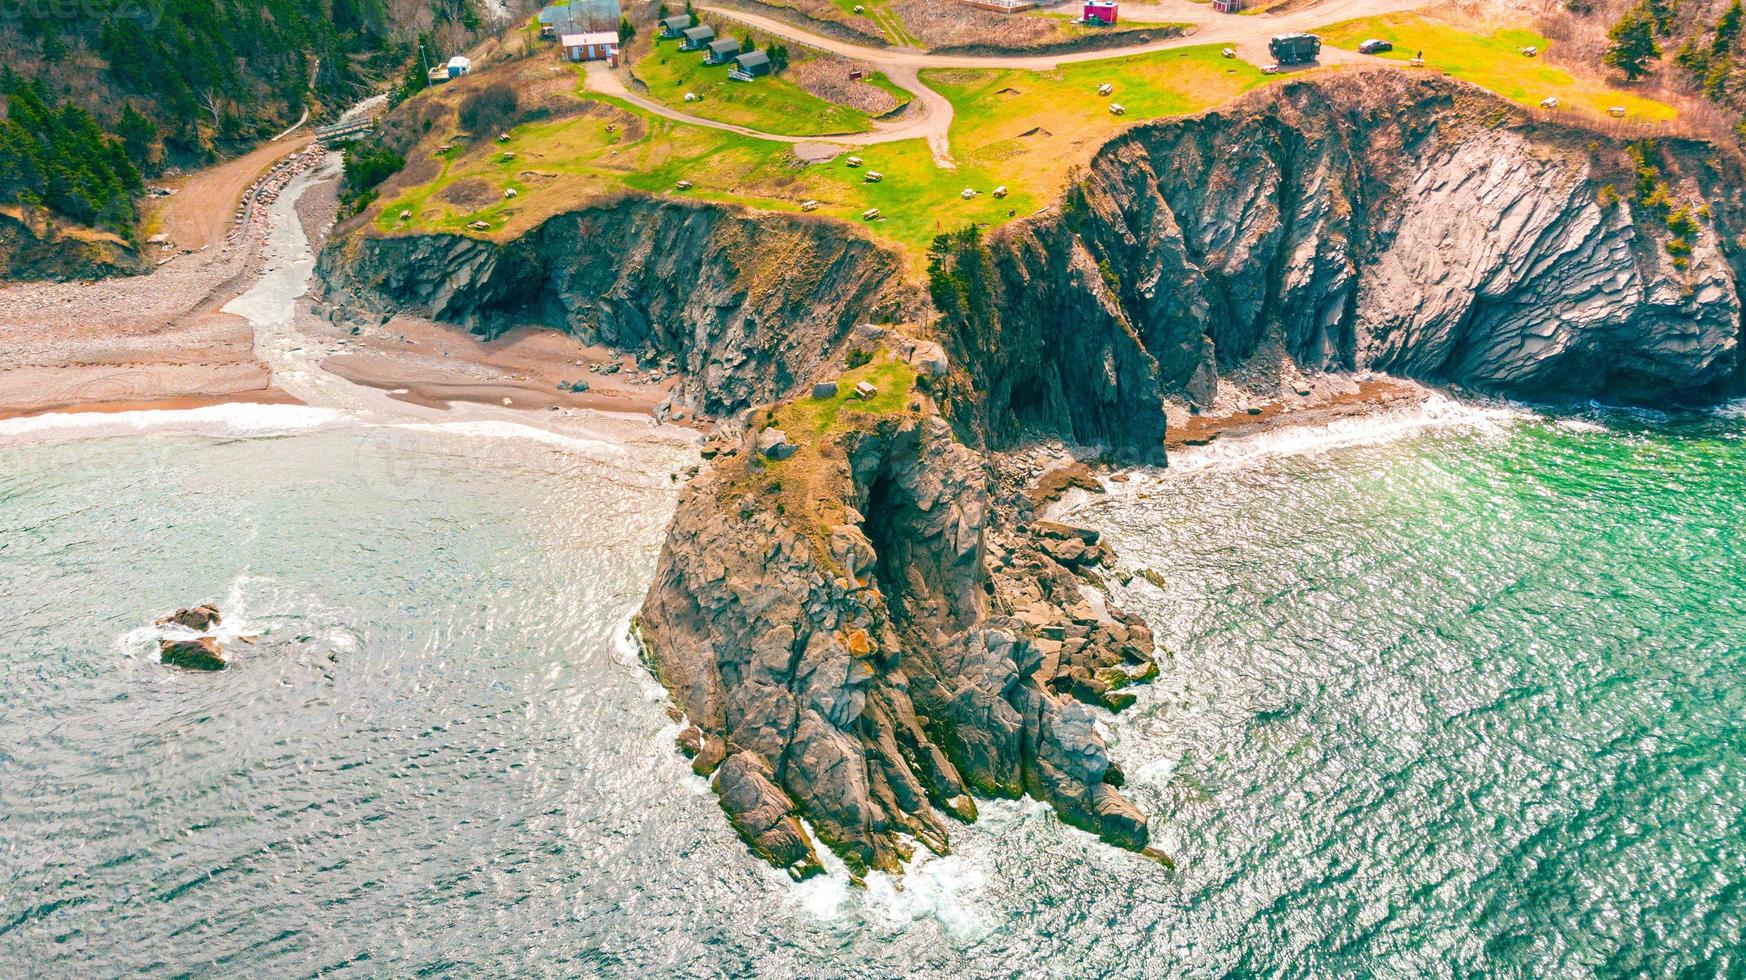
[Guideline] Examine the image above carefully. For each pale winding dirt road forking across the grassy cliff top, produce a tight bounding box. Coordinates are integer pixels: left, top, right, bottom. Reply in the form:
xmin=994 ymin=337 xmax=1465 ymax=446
xmin=587 ymin=0 xmax=1432 ymax=169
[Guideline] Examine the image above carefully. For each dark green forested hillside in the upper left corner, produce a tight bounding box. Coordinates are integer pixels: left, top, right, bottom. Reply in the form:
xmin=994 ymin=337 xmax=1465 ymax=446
xmin=0 ymin=0 xmax=482 ymax=238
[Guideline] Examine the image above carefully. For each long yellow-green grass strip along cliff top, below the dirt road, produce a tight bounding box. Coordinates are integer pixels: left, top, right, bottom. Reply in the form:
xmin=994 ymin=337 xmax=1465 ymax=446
xmin=375 ymin=47 xmax=1264 ymax=263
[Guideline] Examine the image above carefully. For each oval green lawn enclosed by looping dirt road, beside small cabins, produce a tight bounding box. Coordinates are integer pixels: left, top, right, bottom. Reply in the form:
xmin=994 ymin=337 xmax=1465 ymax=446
xmin=636 ymin=42 xmax=873 ymax=136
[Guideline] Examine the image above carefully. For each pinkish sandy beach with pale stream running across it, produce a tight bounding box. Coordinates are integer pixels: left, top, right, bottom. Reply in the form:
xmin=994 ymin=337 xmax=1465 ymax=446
xmin=0 ymin=139 xmax=707 ymax=456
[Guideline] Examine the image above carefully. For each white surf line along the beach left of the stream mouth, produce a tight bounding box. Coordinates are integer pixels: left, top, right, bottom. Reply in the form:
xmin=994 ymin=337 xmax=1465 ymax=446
xmin=0 ymin=402 xmax=349 ymax=442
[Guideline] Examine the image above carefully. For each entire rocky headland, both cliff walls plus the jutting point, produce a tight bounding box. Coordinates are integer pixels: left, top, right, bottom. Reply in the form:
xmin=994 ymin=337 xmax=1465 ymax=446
xmin=320 ymin=73 xmax=1746 ymax=877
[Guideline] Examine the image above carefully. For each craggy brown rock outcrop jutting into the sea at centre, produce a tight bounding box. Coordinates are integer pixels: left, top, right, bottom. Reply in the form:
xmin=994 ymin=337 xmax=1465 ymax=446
xmin=639 ymin=380 xmax=1152 ymax=877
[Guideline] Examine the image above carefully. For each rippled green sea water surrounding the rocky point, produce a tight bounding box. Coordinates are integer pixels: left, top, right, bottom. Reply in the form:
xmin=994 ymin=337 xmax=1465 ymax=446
xmin=0 ymin=407 xmax=1746 ymax=977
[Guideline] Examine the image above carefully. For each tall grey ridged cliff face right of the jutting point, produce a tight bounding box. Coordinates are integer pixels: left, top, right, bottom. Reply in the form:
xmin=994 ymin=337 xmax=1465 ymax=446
xmin=936 ymin=72 xmax=1746 ymax=447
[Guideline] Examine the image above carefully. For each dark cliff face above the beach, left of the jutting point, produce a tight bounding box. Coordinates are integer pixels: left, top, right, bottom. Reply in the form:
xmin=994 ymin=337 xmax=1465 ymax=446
xmin=318 ymin=197 xmax=918 ymax=416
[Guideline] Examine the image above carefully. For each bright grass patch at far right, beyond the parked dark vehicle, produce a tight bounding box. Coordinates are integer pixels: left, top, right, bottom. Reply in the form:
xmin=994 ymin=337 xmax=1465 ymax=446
xmin=1318 ymin=14 xmax=1678 ymax=122
